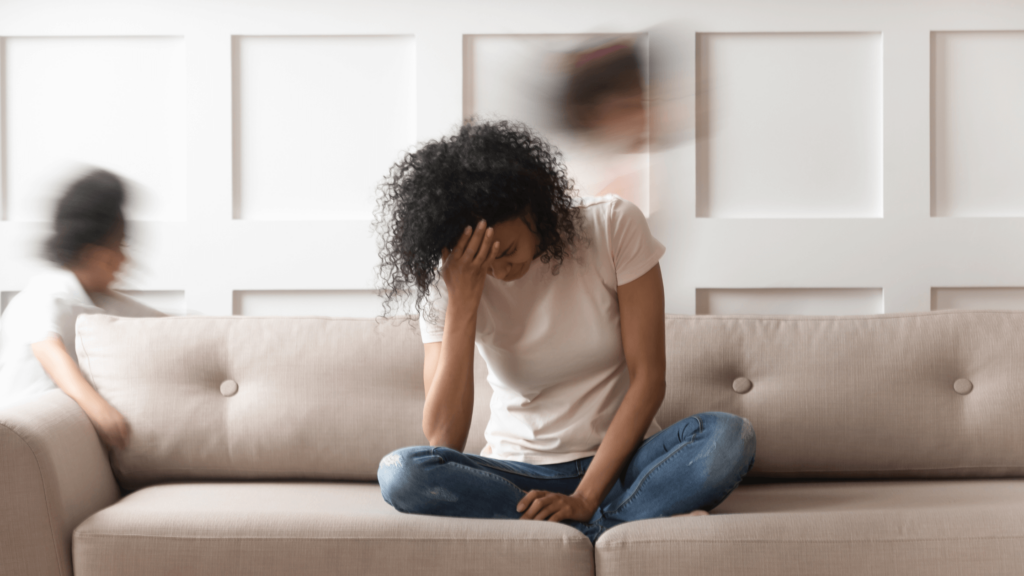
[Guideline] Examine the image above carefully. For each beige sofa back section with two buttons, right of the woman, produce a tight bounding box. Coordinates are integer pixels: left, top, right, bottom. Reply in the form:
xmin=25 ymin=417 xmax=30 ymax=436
xmin=657 ymin=311 xmax=1024 ymax=479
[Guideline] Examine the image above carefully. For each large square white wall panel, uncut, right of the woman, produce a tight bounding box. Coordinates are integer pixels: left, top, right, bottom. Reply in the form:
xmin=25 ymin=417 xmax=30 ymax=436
xmin=696 ymin=33 xmax=882 ymax=218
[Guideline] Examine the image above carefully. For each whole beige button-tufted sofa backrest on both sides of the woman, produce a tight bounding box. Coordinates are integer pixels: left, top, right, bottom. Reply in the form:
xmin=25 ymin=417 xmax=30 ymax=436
xmin=77 ymin=312 xmax=1024 ymax=489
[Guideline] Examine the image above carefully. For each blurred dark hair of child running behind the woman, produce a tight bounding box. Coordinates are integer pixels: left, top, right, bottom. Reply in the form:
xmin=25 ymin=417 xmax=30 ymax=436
xmin=562 ymin=39 xmax=643 ymax=131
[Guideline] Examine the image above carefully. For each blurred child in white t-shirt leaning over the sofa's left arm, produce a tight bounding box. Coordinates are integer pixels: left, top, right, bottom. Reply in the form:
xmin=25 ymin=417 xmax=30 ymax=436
xmin=0 ymin=170 xmax=163 ymax=448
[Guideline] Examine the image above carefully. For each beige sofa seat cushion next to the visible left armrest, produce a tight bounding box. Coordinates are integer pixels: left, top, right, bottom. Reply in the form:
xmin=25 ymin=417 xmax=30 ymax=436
xmin=72 ymin=483 xmax=594 ymax=576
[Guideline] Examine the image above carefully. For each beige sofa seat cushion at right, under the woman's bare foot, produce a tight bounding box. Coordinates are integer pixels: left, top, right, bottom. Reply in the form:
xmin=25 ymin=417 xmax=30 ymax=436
xmin=595 ymin=480 xmax=1024 ymax=576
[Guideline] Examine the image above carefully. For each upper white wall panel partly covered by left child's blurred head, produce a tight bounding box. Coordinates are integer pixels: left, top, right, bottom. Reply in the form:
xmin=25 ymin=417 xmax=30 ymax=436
xmin=3 ymin=37 xmax=185 ymax=221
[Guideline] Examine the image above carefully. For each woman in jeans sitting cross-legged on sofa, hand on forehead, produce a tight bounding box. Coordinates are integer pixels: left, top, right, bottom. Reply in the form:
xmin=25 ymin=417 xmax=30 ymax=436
xmin=377 ymin=122 xmax=755 ymax=541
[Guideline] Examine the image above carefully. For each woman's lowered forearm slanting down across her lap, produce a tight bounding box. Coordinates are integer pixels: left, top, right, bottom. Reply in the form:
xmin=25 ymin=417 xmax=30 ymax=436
xmin=573 ymin=377 xmax=665 ymax=508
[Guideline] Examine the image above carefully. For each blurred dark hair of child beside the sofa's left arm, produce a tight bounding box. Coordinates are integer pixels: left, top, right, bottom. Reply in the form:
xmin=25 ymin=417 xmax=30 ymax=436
xmin=46 ymin=166 xmax=126 ymax=266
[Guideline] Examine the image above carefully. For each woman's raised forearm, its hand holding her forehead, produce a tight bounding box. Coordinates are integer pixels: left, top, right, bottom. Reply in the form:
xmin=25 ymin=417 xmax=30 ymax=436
xmin=423 ymin=302 xmax=476 ymax=451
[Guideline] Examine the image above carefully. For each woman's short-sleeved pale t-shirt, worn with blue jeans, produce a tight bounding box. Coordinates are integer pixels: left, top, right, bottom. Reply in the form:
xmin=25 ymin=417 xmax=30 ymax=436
xmin=420 ymin=196 xmax=665 ymax=464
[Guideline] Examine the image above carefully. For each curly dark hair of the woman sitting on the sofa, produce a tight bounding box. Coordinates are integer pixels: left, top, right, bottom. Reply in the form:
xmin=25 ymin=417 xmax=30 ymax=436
xmin=374 ymin=120 xmax=582 ymax=318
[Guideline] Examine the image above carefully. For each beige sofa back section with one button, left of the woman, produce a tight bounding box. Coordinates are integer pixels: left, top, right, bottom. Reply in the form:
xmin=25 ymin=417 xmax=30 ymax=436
xmin=76 ymin=315 xmax=490 ymax=489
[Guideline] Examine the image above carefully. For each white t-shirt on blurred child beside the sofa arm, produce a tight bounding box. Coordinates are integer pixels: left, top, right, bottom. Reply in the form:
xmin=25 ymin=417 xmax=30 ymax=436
xmin=0 ymin=269 xmax=163 ymax=405
